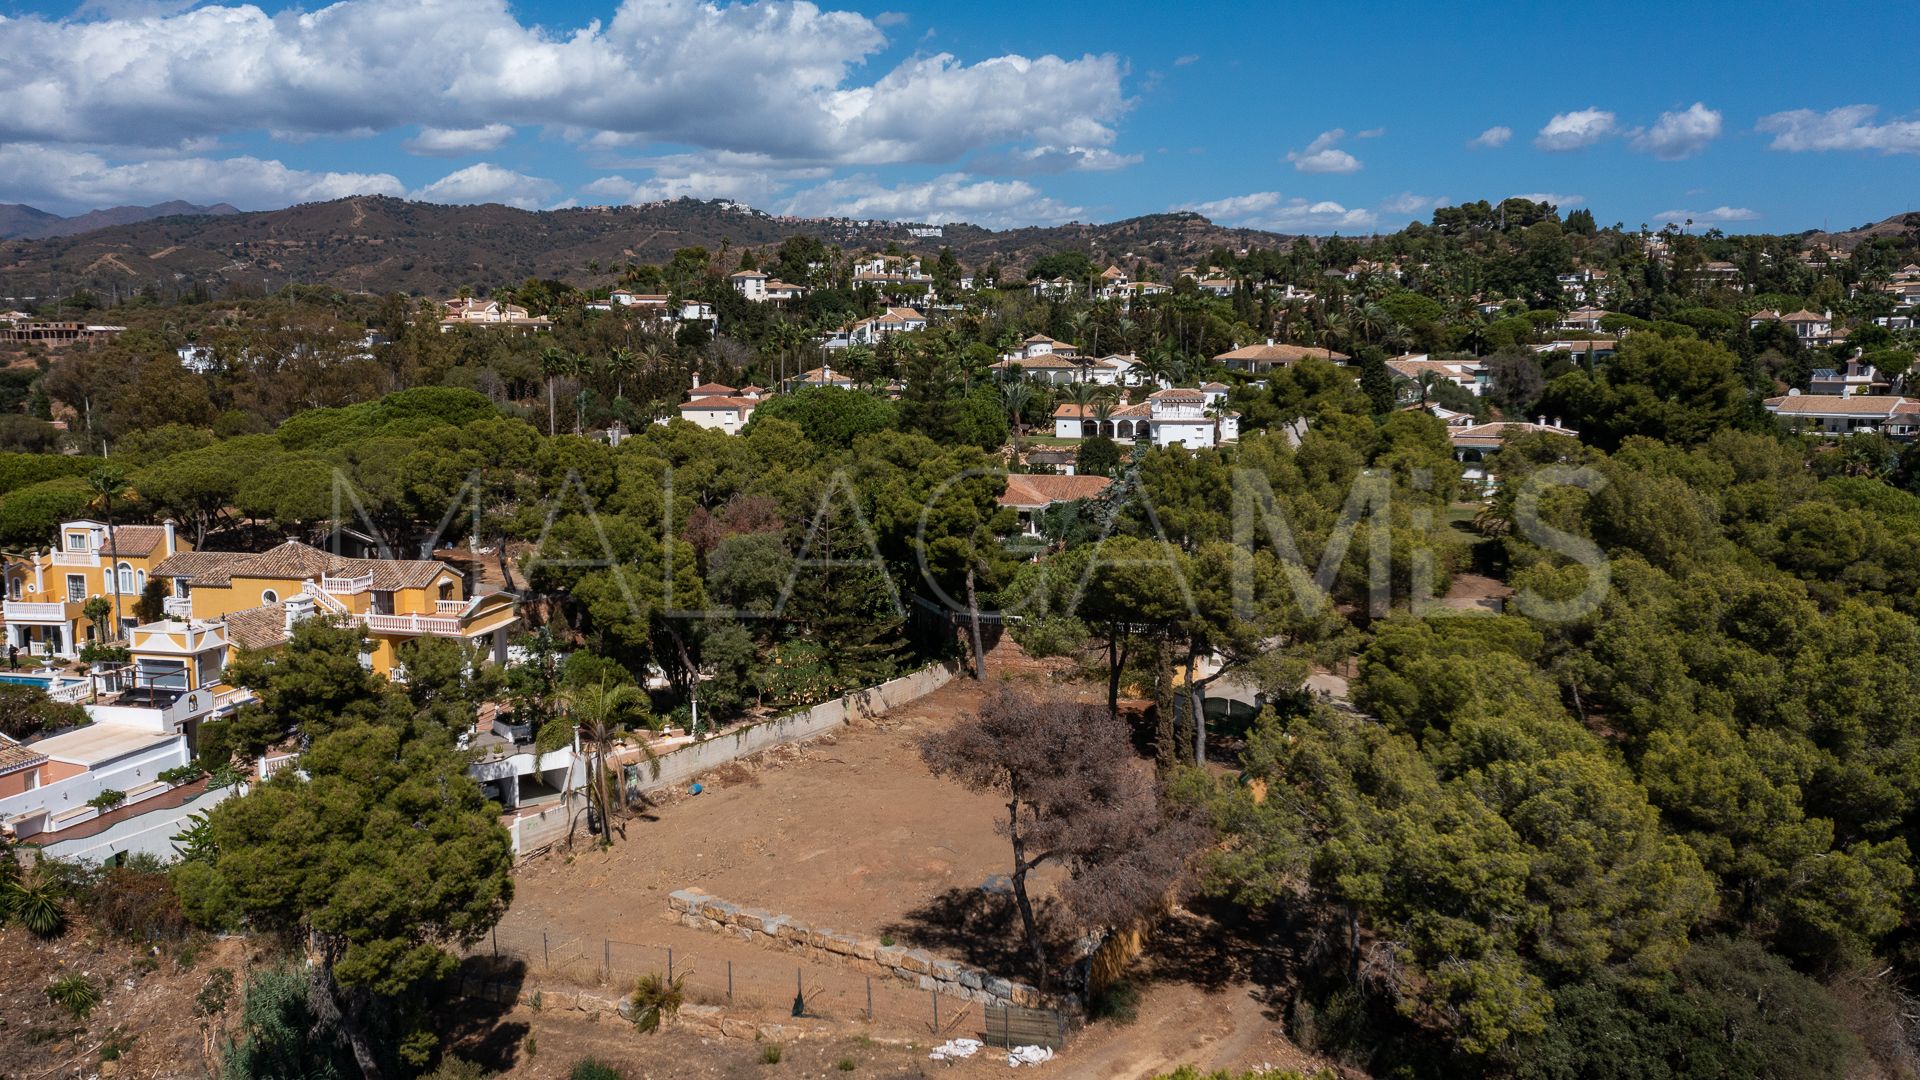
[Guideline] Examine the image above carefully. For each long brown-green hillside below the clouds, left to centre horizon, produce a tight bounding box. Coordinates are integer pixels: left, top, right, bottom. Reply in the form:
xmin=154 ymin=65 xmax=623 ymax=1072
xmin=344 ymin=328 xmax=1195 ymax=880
xmin=0 ymin=196 xmax=1290 ymax=298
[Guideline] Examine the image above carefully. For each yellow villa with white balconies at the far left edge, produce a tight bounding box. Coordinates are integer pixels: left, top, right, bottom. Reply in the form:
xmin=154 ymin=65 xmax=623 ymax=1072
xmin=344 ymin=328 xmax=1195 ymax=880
xmin=0 ymin=521 xmax=192 ymax=659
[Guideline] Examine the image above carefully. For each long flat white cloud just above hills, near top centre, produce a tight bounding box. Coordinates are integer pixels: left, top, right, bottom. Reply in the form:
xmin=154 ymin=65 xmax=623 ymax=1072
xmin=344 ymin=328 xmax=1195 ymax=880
xmin=785 ymin=173 xmax=1083 ymax=227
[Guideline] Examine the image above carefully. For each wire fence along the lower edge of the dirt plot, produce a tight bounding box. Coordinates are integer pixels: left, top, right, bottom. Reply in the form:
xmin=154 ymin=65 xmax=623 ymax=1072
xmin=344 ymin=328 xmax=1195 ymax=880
xmin=465 ymin=928 xmax=1066 ymax=1042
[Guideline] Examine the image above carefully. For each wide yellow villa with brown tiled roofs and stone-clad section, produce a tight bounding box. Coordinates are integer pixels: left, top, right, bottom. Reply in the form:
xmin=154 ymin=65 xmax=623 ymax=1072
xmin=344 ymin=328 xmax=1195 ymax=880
xmin=154 ymin=540 xmax=520 ymax=676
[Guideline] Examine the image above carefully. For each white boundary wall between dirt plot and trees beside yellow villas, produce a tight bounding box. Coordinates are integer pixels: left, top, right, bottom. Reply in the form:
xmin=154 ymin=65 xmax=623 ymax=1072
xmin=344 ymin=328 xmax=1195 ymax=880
xmin=507 ymin=663 xmax=960 ymax=855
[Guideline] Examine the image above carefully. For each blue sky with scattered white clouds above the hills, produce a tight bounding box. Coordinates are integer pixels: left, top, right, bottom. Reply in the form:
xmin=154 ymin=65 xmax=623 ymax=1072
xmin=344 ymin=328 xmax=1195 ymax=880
xmin=0 ymin=0 xmax=1920 ymax=234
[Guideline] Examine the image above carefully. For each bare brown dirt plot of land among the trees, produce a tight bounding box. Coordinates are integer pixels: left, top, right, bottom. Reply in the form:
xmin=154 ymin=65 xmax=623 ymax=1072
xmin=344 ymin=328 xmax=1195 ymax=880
xmin=487 ymin=648 xmax=1315 ymax=1076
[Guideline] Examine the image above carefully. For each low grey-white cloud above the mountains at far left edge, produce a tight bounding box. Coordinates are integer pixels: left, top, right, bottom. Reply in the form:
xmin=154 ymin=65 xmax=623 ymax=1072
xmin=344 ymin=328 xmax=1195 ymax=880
xmin=0 ymin=142 xmax=407 ymax=209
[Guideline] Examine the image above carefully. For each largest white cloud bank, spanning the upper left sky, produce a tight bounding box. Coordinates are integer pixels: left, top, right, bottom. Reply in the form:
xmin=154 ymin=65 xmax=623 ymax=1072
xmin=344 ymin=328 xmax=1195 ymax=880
xmin=0 ymin=0 xmax=1127 ymax=165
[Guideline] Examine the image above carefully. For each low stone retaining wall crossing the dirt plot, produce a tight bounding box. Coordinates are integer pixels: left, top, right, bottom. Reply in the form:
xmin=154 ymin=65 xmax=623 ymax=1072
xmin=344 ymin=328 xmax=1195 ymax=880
xmin=666 ymin=888 xmax=1058 ymax=1009
